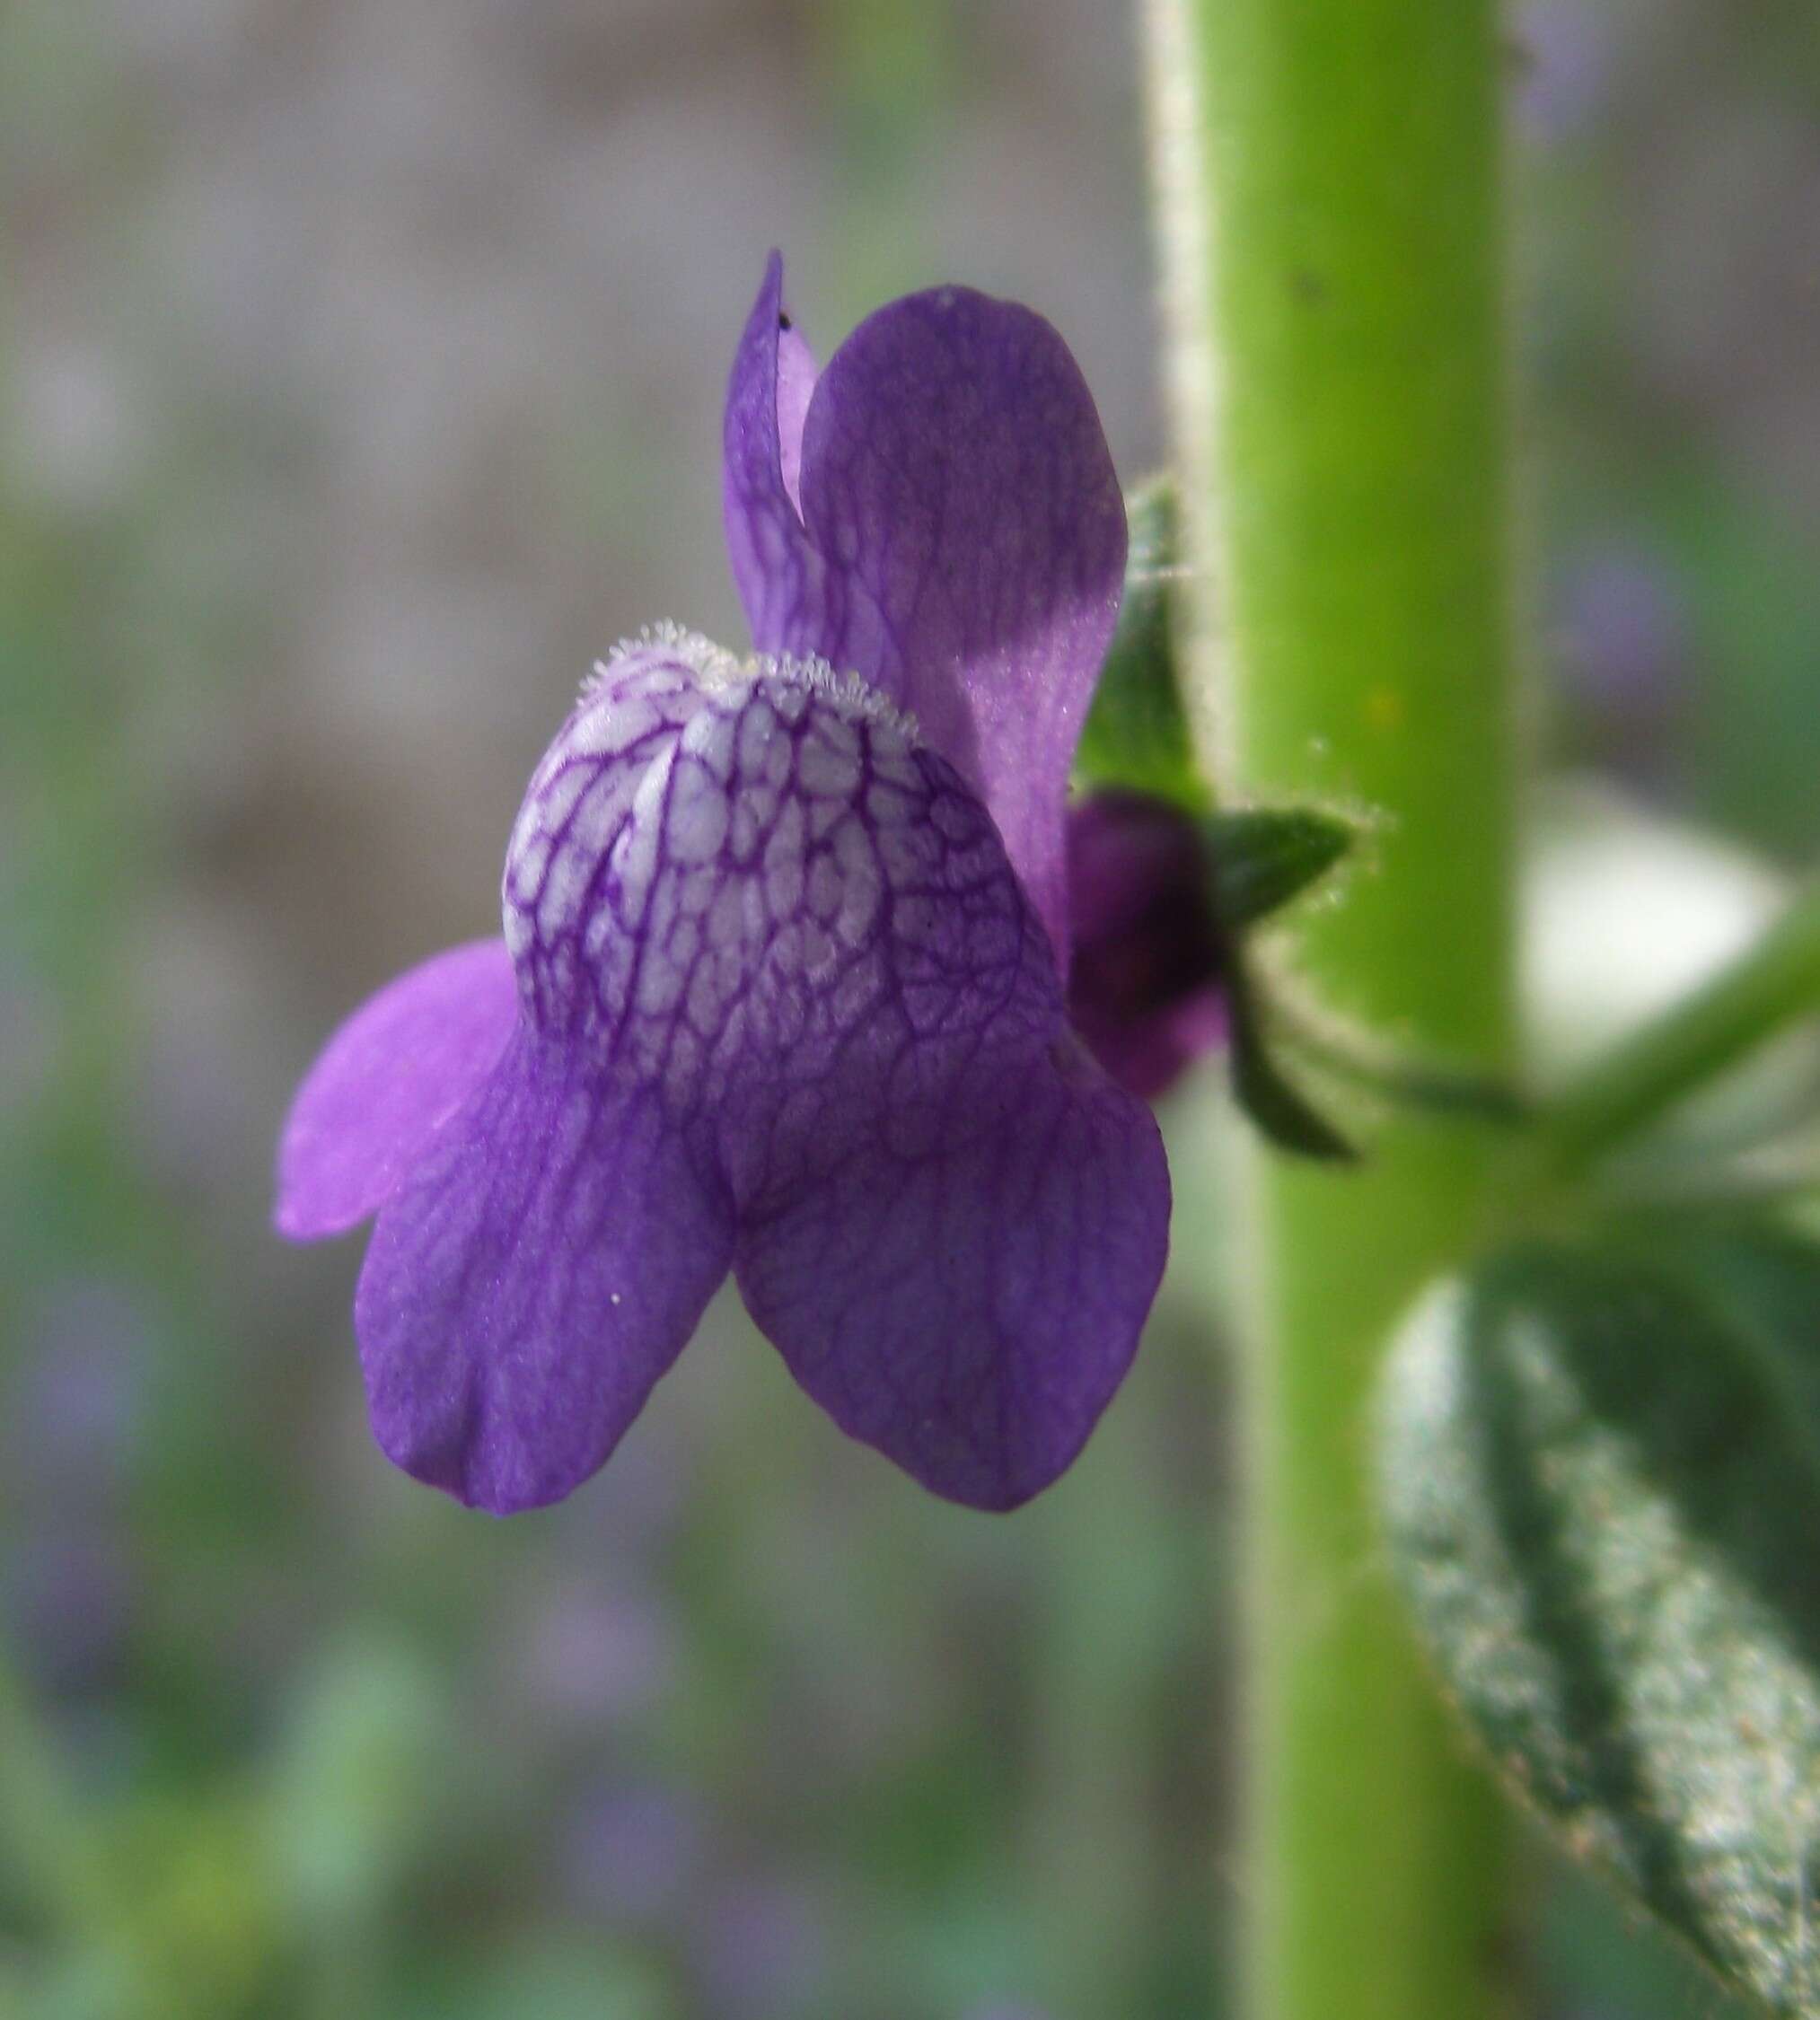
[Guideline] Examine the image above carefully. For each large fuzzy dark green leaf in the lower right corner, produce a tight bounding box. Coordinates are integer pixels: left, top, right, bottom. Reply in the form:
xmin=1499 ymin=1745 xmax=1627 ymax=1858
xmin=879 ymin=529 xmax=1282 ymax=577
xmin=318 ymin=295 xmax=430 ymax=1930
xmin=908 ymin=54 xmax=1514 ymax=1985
xmin=1377 ymin=1225 xmax=1820 ymax=2016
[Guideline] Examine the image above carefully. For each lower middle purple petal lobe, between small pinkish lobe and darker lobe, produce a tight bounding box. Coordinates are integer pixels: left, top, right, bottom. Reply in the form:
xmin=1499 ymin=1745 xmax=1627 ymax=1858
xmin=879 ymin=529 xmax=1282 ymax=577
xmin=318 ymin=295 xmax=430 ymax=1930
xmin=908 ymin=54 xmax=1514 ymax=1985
xmin=354 ymin=1031 xmax=734 ymax=1515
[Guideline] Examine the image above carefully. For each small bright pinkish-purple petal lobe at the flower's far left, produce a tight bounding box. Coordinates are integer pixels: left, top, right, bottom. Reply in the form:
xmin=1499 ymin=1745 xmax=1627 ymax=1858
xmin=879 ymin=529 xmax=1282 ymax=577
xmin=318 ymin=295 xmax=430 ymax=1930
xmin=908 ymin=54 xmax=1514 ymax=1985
xmin=273 ymin=939 xmax=517 ymax=1243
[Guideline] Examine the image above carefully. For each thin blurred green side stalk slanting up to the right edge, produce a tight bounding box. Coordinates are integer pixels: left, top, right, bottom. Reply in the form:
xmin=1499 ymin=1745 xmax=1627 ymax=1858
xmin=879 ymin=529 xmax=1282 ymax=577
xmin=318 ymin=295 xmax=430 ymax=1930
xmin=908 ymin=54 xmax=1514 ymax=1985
xmin=1537 ymin=885 xmax=1820 ymax=1180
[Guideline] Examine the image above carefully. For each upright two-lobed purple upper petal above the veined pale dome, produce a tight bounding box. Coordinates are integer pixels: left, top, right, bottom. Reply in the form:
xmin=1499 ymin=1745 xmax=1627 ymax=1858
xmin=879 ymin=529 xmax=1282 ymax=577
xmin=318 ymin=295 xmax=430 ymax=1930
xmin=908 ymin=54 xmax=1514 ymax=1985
xmin=727 ymin=265 xmax=1125 ymax=962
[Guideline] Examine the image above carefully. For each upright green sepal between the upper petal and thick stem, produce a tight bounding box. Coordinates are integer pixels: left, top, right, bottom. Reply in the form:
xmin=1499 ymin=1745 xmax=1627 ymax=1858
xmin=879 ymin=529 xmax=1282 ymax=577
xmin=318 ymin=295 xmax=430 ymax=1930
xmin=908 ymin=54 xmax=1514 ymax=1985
xmin=1075 ymin=477 xmax=1212 ymax=814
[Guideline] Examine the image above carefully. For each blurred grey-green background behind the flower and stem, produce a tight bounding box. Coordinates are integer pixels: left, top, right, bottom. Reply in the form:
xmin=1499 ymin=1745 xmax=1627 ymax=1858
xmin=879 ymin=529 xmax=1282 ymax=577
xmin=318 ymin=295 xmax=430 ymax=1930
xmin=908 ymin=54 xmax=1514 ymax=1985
xmin=0 ymin=0 xmax=1820 ymax=2020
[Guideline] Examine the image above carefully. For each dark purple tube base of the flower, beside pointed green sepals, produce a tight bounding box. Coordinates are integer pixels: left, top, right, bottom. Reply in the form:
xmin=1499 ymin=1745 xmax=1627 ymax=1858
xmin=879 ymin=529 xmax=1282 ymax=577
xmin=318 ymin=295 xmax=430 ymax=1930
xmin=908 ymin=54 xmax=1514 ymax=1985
xmin=1068 ymin=792 xmax=1227 ymax=1101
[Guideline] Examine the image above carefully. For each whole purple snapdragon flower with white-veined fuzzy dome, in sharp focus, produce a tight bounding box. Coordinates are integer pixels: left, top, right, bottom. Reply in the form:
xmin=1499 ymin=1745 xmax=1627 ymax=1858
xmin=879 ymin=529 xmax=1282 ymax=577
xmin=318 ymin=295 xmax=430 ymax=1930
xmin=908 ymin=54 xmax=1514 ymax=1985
xmin=277 ymin=259 xmax=1170 ymax=1511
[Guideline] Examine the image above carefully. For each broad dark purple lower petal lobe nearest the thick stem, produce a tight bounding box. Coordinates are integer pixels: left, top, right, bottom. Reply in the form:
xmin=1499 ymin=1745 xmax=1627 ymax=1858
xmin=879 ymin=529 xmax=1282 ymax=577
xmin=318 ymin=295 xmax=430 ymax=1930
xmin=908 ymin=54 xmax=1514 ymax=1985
xmin=735 ymin=1026 xmax=1170 ymax=1509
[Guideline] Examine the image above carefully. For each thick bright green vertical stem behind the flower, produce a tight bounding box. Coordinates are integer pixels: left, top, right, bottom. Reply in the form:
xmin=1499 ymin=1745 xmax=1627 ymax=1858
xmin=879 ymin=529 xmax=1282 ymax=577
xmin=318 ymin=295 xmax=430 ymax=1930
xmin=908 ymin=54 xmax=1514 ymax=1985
xmin=1151 ymin=0 xmax=1517 ymax=2020
